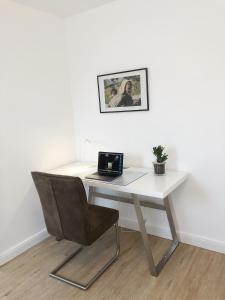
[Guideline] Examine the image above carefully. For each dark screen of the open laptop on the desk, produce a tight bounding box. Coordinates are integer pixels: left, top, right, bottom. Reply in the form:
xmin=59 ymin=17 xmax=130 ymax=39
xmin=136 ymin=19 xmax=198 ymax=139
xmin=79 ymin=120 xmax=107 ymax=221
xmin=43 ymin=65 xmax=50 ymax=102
xmin=98 ymin=152 xmax=123 ymax=176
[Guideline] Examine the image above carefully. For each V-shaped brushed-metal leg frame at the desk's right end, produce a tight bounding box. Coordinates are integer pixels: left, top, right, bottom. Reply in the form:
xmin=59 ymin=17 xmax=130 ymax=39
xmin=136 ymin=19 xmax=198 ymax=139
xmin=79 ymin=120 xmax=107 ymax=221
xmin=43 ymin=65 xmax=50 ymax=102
xmin=132 ymin=195 xmax=179 ymax=276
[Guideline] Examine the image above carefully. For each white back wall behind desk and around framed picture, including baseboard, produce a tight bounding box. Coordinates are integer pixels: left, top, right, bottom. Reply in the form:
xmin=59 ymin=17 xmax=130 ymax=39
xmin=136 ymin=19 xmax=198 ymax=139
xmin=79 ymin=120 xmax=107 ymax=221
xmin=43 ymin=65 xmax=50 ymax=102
xmin=66 ymin=0 xmax=225 ymax=252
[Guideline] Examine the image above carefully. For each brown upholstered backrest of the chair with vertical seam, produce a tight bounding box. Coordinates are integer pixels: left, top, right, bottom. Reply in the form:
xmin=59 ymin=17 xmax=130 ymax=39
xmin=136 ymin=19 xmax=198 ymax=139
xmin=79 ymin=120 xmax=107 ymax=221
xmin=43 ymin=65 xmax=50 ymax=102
xmin=31 ymin=172 xmax=89 ymax=244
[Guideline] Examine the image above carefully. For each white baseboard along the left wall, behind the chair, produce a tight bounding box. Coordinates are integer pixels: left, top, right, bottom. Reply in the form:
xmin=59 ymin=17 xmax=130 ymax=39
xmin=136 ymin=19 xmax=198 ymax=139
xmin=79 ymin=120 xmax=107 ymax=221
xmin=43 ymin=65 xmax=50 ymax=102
xmin=0 ymin=229 xmax=48 ymax=266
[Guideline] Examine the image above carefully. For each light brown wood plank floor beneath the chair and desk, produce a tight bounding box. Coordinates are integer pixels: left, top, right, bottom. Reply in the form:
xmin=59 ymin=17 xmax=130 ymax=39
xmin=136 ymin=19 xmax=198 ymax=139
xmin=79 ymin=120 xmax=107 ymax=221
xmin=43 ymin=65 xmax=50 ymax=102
xmin=0 ymin=227 xmax=225 ymax=300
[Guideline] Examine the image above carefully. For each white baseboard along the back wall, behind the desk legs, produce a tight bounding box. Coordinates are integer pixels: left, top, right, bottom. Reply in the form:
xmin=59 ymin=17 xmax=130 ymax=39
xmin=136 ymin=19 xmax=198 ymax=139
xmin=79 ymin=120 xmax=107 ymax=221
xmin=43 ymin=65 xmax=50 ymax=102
xmin=119 ymin=218 xmax=225 ymax=254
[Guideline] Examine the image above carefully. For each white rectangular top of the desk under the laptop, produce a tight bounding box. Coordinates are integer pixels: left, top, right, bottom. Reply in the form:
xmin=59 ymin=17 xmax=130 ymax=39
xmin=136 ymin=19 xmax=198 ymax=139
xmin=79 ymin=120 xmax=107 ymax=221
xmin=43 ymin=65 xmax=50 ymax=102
xmin=48 ymin=162 xmax=187 ymax=199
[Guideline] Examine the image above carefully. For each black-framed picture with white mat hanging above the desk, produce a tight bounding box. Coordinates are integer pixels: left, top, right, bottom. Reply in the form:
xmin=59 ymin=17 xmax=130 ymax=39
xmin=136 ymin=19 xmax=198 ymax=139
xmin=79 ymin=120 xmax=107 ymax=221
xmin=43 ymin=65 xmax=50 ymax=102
xmin=97 ymin=68 xmax=149 ymax=113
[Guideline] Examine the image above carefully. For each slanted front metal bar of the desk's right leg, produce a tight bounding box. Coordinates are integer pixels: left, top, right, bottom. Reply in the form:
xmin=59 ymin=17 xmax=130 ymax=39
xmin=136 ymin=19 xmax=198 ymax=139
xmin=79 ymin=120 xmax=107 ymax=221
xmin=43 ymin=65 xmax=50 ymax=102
xmin=132 ymin=194 xmax=158 ymax=276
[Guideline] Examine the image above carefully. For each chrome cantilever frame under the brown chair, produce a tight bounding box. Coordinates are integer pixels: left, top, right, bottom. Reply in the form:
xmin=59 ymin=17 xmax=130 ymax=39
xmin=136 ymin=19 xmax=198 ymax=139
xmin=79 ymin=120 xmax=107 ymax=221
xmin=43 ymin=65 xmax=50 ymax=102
xmin=49 ymin=223 xmax=120 ymax=290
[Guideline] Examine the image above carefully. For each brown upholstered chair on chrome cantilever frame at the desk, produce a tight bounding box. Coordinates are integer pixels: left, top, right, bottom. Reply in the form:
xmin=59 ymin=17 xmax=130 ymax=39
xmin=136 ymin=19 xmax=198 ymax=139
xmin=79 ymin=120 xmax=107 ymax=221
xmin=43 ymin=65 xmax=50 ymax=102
xmin=31 ymin=172 xmax=120 ymax=290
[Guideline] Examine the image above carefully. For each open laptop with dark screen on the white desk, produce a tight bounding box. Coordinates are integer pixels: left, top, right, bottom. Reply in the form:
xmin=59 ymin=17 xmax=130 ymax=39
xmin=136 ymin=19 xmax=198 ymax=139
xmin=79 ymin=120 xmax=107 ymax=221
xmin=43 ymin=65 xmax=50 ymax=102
xmin=85 ymin=152 xmax=123 ymax=182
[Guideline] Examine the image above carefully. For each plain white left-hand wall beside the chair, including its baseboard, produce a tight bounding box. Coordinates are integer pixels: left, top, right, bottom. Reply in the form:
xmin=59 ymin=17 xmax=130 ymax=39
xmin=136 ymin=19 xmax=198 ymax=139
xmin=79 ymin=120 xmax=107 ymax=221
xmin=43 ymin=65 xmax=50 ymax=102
xmin=0 ymin=0 xmax=74 ymax=263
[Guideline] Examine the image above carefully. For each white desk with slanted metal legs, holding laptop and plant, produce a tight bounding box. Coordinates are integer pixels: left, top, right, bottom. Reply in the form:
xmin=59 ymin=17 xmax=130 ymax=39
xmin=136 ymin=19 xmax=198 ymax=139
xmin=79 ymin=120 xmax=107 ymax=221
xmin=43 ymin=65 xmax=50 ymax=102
xmin=48 ymin=162 xmax=187 ymax=276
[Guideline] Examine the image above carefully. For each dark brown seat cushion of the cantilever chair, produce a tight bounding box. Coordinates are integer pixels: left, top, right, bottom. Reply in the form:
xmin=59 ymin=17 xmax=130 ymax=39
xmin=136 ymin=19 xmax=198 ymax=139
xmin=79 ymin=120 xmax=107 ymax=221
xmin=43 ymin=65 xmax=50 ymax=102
xmin=88 ymin=204 xmax=119 ymax=245
